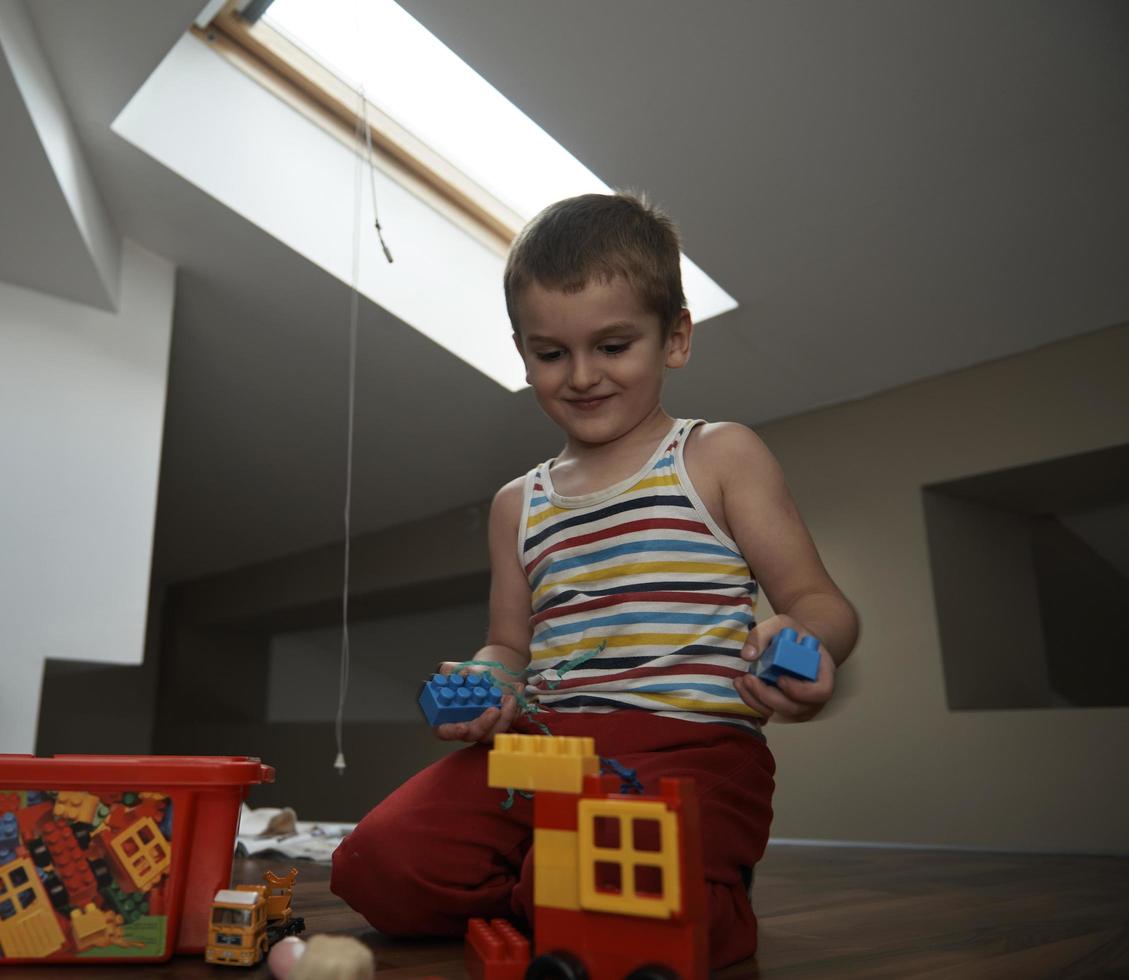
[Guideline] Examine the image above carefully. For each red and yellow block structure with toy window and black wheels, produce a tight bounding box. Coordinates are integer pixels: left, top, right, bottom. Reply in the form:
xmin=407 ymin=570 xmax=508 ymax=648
xmin=465 ymin=734 xmax=709 ymax=980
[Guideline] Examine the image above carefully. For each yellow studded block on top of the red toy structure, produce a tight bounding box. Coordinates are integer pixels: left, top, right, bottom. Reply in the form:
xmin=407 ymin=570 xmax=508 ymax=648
xmin=487 ymin=734 xmax=599 ymax=794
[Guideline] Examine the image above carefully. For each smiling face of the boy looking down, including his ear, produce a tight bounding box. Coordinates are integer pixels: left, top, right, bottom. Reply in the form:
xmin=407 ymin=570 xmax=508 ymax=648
xmin=514 ymin=277 xmax=692 ymax=445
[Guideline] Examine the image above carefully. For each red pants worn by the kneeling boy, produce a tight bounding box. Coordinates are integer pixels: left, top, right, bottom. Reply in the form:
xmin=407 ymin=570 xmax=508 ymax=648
xmin=331 ymin=710 xmax=776 ymax=969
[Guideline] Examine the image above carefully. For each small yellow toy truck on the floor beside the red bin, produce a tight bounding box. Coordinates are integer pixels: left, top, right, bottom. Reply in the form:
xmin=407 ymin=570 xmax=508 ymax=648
xmin=204 ymin=868 xmax=306 ymax=966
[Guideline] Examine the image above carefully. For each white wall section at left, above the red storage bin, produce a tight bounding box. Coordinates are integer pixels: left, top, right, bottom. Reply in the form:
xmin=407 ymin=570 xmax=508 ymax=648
xmin=0 ymin=243 xmax=174 ymax=752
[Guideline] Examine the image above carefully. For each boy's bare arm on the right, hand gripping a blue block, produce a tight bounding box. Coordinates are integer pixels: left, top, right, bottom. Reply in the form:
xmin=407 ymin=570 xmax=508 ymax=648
xmin=699 ymin=423 xmax=858 ymax=721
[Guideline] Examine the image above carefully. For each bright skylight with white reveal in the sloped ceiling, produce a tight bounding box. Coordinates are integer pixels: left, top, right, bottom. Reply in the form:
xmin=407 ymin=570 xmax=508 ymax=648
xmin=189 ymin=0 xmax=737 ymax=391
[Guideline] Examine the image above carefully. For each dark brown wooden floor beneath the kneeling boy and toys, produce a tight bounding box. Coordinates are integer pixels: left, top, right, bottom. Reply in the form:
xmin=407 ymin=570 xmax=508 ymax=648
xmin=11 ymin=846 xmax=1129 ymax=980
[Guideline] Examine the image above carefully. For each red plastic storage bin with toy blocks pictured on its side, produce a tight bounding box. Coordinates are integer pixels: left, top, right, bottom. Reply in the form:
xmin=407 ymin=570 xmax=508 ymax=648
xmin=0 ymin=754 xmax=274 ymax=966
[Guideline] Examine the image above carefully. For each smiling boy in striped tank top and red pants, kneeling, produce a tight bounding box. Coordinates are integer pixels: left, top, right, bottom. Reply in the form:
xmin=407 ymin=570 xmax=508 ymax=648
xmin=332 ymin=194 xmax=858 ymax=968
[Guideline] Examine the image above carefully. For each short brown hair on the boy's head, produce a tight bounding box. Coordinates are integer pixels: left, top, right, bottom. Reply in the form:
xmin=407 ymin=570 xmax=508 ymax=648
xmin=502 ymin=191 xmax=686 ymax=338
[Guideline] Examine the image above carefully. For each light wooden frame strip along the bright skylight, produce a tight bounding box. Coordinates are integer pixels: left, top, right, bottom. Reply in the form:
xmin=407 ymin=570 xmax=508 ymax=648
xmin=191 ymin=0 xmax=525 ymax=255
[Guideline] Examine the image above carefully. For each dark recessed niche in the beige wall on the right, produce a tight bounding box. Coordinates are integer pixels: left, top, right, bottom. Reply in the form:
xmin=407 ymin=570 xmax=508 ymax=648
xmin=922 ymin=445 xmax=1129 ymax=710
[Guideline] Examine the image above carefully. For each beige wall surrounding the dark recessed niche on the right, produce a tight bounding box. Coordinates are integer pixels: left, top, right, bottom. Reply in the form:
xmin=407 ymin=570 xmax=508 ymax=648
xmin=759 ymin=325 xmax=1129 ymax=852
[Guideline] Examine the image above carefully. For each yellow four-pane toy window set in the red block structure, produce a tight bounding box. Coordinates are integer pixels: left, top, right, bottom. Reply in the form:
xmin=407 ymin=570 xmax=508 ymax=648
xmin=577 ymin=799 xmax=682 ymax=919
